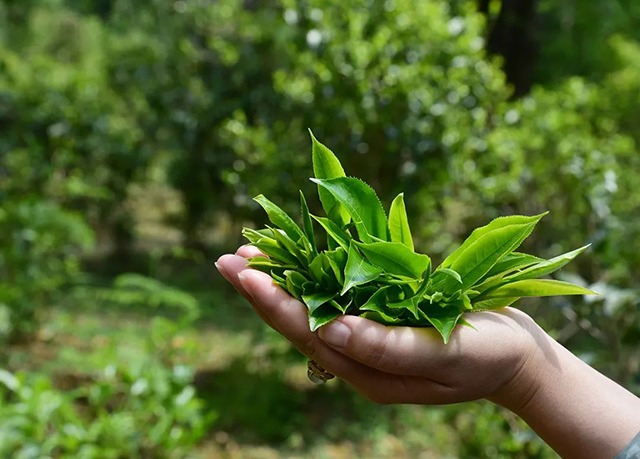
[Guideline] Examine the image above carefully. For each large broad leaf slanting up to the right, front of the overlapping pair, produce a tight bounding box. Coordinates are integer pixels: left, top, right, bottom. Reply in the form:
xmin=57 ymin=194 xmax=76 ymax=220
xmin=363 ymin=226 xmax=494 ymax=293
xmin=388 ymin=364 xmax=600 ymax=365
xmin=451 ymin=220 xmax=537 ymax=289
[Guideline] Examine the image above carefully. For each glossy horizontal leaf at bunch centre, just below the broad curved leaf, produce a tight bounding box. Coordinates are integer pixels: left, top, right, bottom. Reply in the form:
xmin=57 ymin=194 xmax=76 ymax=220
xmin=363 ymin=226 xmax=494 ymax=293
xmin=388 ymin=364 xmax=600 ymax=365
xmin=354 ymin=241 xmax=431 ymax=279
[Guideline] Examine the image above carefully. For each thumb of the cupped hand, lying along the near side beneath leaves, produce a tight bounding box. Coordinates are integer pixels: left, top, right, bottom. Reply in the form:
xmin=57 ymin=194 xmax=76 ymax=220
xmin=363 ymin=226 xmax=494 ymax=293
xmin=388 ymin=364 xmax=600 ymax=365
xmin=319 ymin=316 xmax=455 ymax=376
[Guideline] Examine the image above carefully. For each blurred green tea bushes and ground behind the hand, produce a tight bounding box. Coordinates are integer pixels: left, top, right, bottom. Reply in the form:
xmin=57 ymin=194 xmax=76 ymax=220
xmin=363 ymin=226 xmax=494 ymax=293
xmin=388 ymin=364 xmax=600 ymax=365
xmin=0 ymin=0 xmax=640 ymax=458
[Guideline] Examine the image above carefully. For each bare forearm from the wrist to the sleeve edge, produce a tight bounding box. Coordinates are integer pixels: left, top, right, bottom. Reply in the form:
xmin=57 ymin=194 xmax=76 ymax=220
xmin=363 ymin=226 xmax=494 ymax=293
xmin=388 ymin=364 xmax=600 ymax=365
xmin=494 ymin=330 xmax=640 ymax=459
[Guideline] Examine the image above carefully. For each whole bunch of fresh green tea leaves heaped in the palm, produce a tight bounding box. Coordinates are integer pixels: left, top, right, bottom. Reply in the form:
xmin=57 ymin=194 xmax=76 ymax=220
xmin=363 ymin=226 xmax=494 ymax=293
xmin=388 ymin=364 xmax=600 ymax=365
xmin=243 ymin=134 xmax=593 ymax=343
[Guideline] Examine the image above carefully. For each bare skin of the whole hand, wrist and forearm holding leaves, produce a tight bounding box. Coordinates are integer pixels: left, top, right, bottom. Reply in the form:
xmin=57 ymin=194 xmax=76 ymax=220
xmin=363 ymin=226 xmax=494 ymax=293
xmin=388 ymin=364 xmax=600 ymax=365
xmin=216 ymin=246 xmax=640 ymax=459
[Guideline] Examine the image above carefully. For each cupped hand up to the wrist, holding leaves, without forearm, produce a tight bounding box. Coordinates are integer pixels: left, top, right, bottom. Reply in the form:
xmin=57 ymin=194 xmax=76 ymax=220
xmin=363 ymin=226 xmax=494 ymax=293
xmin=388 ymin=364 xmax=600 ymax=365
xmin=216 ymin=246 xmax=544 ymax=405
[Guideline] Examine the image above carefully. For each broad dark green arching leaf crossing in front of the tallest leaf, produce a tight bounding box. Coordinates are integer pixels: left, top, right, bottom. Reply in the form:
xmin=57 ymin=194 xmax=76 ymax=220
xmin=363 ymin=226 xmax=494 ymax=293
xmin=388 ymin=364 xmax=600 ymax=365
xmin=311 ymin=177 xmax=389 ymax=242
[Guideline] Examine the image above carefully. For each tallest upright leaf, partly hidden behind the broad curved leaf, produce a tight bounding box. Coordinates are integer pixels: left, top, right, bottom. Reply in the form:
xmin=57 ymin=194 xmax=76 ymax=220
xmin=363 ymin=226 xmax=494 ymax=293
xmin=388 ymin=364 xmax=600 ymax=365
xmin=309 ymin=129 xmax=350 ymax=227
